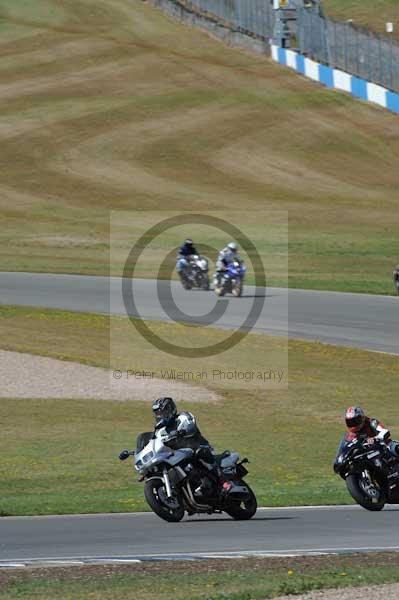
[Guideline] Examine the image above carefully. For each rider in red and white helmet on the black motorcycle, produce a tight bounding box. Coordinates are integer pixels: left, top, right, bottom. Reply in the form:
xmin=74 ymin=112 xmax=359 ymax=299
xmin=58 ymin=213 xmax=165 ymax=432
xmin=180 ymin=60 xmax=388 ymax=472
xmin=343 ymin=406 xmax=399 ymax=458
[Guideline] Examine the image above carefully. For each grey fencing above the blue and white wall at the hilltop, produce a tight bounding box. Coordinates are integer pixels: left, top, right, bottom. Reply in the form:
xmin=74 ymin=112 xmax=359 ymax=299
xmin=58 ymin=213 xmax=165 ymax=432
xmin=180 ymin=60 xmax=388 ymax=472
xmin=177 ymin=0 xmax=399 ymax=91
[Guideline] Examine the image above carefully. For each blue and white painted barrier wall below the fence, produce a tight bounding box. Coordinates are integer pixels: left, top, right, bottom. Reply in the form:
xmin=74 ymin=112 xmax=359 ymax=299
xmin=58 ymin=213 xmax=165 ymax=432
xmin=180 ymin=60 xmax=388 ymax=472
xmin=271 ymin=45 xmax=399 ymax=113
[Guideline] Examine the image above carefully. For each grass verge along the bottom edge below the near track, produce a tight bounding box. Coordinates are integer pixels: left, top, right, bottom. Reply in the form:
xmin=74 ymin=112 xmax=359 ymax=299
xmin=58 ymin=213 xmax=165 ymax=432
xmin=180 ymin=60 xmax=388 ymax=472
xmin=0 ymin=553 xmax=399 ymax=600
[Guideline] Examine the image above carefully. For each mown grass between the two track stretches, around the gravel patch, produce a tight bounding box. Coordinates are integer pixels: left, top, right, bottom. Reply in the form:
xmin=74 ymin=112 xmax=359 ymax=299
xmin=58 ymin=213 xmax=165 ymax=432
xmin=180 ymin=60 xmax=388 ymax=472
xmin=0 ymin=307 xmax=399 ymax=515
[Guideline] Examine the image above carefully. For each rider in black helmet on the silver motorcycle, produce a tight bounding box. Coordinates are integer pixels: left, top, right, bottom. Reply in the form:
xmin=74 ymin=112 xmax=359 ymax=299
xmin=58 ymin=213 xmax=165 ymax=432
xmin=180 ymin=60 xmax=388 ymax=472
xmin=152 ymin=397 xmax=234 ymax=495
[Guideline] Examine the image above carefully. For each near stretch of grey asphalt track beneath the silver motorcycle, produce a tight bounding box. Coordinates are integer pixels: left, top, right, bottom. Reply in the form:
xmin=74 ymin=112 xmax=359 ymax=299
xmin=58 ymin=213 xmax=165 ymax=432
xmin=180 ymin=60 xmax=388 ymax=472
xmin=0 ymin=506 xmax=399 ymax=567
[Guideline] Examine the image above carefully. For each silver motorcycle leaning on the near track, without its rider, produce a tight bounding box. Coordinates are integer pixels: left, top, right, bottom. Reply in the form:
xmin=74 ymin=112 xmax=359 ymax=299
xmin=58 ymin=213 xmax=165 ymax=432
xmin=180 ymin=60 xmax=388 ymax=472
xmin=119 ymin=430 xmax=257 ymax=522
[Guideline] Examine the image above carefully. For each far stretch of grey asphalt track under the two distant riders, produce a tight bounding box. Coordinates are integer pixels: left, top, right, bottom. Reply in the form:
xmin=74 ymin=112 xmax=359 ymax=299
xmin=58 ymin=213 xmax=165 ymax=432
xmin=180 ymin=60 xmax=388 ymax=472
xmin=0 ymin=273 xmax=399 ymax=354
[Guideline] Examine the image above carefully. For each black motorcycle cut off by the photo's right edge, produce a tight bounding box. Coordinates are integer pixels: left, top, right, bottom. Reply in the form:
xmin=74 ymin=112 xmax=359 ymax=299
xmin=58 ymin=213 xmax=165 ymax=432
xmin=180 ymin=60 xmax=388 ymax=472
xmin=334 ymin=438 xmax=399 ymax=511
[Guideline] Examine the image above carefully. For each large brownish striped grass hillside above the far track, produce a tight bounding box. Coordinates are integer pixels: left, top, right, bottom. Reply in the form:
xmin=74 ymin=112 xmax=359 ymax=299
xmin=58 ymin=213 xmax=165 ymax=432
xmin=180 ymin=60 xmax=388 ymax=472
xmin=0 ymin=0 xmax=399 ymax=293
